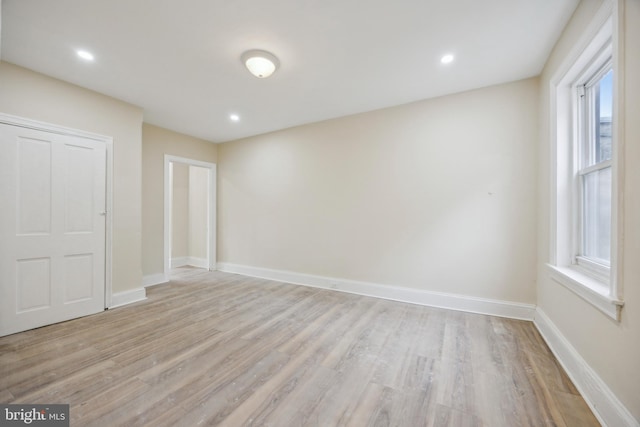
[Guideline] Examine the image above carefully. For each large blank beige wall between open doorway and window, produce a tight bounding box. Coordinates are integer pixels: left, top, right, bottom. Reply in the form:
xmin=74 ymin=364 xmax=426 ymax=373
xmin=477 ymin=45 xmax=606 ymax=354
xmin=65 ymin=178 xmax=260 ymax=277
xmin=218 ymin=79 xmax=538 ymax=303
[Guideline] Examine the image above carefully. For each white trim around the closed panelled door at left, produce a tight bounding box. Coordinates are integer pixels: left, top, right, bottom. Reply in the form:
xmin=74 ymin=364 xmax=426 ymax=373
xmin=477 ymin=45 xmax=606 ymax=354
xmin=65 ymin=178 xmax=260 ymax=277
xmin=0 ymin=113 xmax=113 ymax=308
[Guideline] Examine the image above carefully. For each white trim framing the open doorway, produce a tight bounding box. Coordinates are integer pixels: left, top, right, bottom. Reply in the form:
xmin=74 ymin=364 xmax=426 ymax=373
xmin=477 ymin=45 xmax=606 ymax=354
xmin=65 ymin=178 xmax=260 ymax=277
xmin=164 ymin=154 xmax=217 ymax=277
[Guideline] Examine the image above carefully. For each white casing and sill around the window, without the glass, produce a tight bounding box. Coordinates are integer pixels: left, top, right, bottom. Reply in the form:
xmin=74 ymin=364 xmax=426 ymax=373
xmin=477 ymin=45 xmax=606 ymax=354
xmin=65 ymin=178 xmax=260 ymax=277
xmin=547 ymin=0 xmax=624 ymax=321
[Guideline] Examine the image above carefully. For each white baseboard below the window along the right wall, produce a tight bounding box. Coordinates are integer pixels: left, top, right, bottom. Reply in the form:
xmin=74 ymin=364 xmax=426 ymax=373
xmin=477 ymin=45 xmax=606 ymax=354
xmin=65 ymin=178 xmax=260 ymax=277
xmin=533 ymin=307 xmax=640 ymax=427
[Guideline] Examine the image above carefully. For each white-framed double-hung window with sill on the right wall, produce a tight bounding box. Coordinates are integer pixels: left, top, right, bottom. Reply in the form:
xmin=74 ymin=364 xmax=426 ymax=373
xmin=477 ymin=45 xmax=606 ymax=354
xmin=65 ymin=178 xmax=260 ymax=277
xmin=548 ymin=10 xmax=623 ymax=319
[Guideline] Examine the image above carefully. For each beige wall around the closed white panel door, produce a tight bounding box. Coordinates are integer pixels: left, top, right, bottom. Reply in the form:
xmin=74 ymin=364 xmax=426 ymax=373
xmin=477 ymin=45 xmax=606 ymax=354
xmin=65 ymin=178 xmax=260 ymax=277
xmin=0 ymin=62 xmax=142 ymax=293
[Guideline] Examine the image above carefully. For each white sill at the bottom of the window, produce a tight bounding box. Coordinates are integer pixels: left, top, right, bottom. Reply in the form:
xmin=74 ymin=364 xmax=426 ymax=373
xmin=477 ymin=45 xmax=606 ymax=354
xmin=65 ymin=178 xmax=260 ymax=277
xmin=547 ymin=264 xmax=624 ymax=321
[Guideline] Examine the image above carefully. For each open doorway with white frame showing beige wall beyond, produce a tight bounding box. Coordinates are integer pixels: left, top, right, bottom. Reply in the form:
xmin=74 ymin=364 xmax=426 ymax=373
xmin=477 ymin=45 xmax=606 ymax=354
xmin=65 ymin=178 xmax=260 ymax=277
xmin=164 ymin=155 xmax=216 ymax=277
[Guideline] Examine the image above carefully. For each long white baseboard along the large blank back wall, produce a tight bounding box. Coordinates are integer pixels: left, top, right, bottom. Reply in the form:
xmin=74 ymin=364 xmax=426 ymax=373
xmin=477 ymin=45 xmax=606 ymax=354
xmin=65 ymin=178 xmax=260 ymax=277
xmin=216 ymin=262 xmax=535 ymax=320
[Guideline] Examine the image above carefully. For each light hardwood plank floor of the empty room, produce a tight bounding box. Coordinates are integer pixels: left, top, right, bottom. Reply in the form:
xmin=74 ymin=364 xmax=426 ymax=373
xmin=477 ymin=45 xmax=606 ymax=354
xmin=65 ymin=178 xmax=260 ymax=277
xmin=0 ymin=268 xmax=599 ymax=427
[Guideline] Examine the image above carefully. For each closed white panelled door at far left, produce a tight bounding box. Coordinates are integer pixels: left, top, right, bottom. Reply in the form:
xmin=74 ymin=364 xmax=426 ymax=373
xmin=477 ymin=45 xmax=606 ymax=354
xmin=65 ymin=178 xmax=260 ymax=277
xmin=0 ymin=124 xmax=106 ymax=336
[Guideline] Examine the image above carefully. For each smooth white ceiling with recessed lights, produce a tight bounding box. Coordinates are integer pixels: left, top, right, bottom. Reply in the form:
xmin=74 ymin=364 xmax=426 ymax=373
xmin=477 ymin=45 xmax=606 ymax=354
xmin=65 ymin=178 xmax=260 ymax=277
xmin=0 ymin=0 xmax=578 ymax=142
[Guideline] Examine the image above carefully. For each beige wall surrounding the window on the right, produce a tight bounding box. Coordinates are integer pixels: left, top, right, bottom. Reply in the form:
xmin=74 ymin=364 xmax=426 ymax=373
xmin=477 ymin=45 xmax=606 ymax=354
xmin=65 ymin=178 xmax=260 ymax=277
xmin=538 ymin=0 xmax=640 ymax=420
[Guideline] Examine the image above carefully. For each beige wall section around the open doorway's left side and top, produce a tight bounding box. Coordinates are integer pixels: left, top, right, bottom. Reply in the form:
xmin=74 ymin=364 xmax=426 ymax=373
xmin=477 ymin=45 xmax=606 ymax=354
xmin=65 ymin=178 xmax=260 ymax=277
xmin=142 ymin=123 xmax=218 ymax=276
